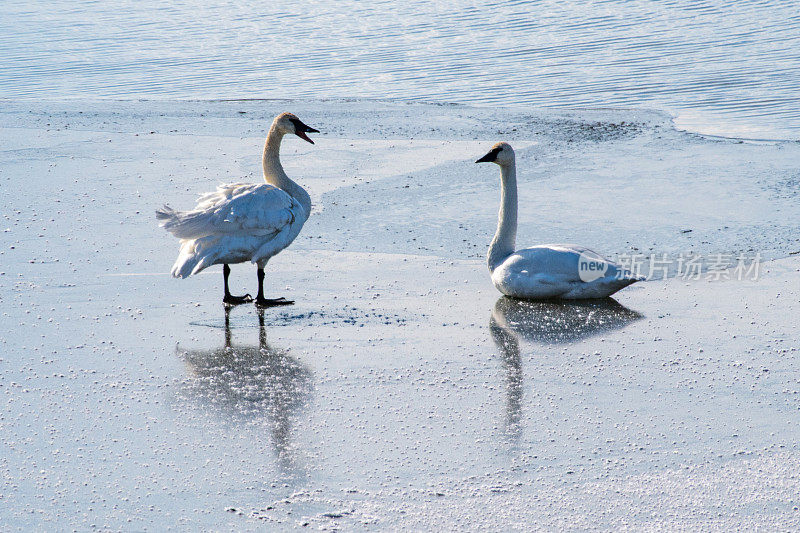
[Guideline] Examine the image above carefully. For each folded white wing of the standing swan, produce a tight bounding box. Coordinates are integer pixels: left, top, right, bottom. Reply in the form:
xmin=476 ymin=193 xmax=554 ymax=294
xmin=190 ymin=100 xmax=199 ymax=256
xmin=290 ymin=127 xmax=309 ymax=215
xmin=163 ymin=183 xmax=302 ymax=239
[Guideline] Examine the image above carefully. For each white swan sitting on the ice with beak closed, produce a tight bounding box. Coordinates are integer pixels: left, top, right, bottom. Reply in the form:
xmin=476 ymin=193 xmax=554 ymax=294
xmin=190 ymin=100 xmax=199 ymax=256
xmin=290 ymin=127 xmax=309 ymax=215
xmin=476 ymin=143 xmax=640 ymax=300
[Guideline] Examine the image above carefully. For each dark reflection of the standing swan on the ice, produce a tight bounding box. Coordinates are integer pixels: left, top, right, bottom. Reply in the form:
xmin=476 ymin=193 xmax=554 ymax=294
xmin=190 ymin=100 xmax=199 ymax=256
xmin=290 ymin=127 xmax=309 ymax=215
xmin=176 ymin=308 xmax=313 ymax=473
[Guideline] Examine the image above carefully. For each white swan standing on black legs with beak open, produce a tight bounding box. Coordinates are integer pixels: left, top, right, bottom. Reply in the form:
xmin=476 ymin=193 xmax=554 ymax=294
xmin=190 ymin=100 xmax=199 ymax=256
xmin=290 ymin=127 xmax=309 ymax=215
xmin=156 ymin=113 xmax=319 ymax=307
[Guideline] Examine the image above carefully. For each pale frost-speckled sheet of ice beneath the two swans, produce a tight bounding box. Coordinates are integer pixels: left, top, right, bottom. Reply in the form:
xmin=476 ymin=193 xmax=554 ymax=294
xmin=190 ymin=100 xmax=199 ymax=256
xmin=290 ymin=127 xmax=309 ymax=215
xmin=0 ymin=101 xmax=800 ymax=531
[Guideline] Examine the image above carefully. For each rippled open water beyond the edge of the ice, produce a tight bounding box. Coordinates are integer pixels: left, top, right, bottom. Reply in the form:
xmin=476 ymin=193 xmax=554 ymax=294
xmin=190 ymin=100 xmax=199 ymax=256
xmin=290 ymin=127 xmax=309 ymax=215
xmin=0 ymin=0 xmax=800 ymax=139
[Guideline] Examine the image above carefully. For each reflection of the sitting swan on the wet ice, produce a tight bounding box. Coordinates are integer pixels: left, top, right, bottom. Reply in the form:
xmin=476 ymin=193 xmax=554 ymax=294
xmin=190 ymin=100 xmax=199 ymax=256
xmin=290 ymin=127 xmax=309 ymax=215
xmin=489 ymin=296 xmax=642 ymax=442
